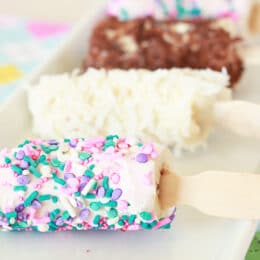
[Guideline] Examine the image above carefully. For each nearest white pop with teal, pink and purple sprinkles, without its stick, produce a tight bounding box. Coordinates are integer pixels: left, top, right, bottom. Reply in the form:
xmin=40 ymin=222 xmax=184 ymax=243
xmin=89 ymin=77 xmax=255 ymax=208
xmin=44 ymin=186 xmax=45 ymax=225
xmin=0 ymin=135 xmax=175 ymax=232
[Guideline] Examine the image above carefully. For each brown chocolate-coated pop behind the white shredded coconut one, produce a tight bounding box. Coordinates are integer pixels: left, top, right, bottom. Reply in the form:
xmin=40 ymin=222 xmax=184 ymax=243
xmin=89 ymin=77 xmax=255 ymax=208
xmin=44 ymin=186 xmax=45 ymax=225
xmin=83 ymin=17 xmax=243 ymax=86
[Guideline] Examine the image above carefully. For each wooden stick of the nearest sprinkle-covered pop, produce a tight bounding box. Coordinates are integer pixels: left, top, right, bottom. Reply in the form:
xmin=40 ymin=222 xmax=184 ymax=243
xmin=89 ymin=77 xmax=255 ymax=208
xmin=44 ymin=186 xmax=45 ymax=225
xmin=159 ymin=169 xmax=260 ymax=220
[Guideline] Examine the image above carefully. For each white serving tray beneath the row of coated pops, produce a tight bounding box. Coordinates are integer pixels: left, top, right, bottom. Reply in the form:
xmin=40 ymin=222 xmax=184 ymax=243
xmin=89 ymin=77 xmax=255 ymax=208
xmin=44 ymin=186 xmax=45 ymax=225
xmin=0 ymin=11 xmax=260 ymax=260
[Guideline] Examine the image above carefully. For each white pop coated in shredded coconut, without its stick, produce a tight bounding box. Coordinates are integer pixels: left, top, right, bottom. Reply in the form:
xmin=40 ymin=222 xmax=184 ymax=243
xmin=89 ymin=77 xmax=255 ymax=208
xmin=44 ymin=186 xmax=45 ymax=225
xmin=28 ymin=69 xmax=231 ymax=152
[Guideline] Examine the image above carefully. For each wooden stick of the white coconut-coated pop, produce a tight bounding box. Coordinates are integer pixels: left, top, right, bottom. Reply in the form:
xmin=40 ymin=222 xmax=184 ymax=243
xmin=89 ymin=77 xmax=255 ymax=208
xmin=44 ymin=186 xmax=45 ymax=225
xmin=214 ymin=101 xmax=260 ymax=139
